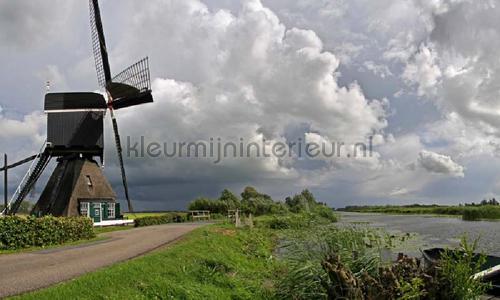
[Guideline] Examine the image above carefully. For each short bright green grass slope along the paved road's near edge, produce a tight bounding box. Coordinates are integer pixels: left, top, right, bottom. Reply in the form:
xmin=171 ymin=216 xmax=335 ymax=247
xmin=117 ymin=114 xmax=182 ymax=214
xmin=13 ymin=225 xmax=277 ymax=299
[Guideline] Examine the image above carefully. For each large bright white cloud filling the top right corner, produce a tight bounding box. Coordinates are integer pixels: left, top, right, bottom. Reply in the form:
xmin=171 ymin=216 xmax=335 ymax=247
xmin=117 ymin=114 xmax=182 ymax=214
xmin=396 ymin=1 xmax=500 ymax=135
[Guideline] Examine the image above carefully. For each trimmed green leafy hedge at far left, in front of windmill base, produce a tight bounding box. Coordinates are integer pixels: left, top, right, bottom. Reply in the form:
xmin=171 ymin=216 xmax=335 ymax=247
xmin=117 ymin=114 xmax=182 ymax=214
xmin=0 ymin=216 xmax=95 ymax=250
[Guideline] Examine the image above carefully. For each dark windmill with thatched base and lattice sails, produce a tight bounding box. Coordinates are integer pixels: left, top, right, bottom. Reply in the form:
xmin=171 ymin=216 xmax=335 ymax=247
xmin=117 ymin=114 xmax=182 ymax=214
xmin=2 ymin=0 xmax=153 ymax=221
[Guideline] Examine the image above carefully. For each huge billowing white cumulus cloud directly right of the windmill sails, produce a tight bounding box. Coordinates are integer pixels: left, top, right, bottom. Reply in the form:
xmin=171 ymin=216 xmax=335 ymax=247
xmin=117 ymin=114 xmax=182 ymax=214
xmin=100 ymin=0 xmax=388 ymax=191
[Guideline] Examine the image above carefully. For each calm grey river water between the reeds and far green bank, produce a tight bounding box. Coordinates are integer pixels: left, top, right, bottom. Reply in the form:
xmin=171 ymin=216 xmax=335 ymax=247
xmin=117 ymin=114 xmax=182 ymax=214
xmin=340 ymin=212 xmax=500 ymax=256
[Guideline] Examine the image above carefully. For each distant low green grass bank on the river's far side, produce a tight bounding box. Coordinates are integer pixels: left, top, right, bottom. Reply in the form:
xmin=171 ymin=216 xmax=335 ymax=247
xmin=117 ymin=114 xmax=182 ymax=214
xmin=343 ymin=205 xmax=500 ymax=221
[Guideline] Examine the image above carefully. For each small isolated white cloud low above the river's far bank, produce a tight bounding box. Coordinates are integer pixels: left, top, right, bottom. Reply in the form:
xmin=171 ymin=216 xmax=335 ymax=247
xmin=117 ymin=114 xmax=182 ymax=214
xmin=417 ymin=150 xmax=464 ymax=177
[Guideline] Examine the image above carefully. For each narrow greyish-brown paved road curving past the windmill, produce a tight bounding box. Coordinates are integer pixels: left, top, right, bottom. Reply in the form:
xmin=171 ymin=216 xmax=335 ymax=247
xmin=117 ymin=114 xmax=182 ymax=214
xmin=0 ymin=223 xmax=204 ymax=298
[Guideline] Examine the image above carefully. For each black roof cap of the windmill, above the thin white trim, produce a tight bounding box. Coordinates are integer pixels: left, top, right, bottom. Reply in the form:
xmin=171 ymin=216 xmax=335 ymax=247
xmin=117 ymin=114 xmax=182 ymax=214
xmin=44 ymin=93 xmax=107 ymax=111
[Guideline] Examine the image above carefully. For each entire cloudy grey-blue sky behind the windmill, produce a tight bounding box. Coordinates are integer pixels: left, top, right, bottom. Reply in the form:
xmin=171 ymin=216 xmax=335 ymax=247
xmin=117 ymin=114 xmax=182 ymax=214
xmin=0 ymin=0 xmax=500 ymax=210
